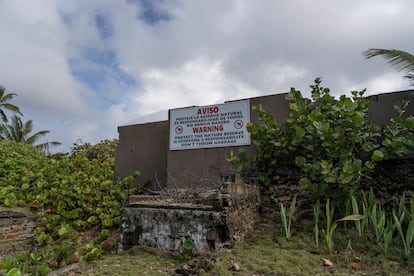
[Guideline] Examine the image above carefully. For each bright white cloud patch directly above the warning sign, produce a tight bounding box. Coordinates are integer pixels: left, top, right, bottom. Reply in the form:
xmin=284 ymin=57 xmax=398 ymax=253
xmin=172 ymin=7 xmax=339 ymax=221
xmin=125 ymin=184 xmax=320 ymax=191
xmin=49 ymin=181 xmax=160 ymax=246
xmin=134 ymin=58 xmax=258 ymax=115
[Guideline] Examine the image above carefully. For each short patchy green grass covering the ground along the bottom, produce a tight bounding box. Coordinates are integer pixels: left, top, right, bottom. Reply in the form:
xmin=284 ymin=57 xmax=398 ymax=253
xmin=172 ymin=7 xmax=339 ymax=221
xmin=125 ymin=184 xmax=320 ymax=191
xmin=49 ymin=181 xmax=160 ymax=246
xmin=59 ymin=224 xmax=414 ymax=276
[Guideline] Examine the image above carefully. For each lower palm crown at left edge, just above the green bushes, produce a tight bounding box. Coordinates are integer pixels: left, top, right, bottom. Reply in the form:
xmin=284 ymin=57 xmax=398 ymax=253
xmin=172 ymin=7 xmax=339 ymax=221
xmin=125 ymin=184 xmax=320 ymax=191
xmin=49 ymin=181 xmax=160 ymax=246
xmin=0 ymin=115 xmax=61 ymax=149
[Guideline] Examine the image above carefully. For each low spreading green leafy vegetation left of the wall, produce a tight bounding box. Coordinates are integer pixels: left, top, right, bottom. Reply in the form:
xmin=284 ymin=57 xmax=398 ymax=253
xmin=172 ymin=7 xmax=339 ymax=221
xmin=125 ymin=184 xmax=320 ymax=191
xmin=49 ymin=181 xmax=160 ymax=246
xmin=0 ymin=140 xmax=138 ymax=275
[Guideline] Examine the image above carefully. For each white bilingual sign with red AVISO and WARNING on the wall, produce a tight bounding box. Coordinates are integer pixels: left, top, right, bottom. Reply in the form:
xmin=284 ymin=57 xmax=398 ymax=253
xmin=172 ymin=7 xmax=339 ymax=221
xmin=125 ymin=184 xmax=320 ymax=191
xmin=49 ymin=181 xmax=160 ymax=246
xmin=170 ymin=100 xmax=250 ymax=150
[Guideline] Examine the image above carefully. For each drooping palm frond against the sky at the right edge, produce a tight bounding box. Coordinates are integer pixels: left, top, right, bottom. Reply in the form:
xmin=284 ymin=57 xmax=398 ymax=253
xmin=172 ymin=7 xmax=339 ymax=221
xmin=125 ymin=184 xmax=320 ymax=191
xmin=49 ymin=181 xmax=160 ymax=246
xmin=363 ymin=49 xmax=414 ymax=85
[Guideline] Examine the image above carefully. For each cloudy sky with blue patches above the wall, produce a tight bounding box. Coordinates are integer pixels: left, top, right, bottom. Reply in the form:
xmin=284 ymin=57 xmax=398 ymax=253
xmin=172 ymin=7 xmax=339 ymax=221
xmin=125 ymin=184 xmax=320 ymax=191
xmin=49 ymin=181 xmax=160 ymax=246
xmin=0 ymin=0 xmax=414 ymax=151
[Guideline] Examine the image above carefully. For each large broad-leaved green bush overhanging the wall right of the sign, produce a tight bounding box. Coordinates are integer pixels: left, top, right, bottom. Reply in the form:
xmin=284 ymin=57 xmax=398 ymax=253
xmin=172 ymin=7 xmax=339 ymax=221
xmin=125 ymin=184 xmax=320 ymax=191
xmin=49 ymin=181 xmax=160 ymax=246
xmin=226 ymin=79 xmax=414 ymax=203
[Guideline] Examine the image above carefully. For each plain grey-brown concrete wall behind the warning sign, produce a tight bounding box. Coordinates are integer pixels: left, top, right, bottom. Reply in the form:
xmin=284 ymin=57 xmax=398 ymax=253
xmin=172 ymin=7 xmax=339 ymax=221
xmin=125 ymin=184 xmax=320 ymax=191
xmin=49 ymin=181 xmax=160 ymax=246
xmin=115 ymin=90 xmax=414 ymax=188
